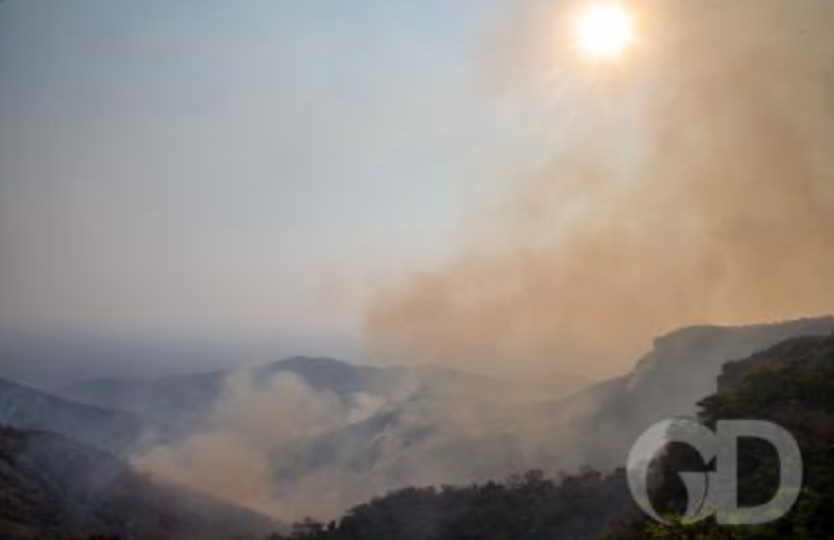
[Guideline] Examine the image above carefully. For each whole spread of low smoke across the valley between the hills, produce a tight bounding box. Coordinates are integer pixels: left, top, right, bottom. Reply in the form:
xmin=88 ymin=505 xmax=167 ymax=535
xmin=131 ymin=369 xmax=560 ymax=522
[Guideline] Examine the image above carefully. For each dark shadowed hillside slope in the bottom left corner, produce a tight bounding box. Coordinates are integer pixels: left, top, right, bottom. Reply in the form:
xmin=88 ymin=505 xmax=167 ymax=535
xmin=0 ymin=427 xmax=280 ymax=540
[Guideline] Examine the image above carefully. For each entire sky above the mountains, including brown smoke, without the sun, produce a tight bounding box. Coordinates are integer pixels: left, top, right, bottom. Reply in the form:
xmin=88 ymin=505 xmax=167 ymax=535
xmin=0 ymin=0 xmax=834 ymax=377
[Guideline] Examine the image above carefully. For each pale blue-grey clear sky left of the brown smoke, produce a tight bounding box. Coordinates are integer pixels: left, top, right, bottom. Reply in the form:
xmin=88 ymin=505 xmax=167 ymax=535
xmin=0 ymin=0 xmax=524 ymax=353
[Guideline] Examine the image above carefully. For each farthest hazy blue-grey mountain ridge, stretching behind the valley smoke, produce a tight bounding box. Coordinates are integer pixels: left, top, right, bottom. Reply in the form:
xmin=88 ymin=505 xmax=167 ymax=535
xmin=55 ymin=356 xmax=587 ymax=430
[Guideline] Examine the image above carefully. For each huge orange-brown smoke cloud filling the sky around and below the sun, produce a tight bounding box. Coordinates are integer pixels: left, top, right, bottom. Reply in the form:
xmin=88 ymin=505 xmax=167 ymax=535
xmin=367 ymin=0 xmax=834 ymax=380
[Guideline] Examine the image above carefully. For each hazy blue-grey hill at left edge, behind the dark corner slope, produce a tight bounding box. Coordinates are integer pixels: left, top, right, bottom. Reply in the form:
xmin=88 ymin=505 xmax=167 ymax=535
xmin=0 ymin=379 xmax=164 ymax=454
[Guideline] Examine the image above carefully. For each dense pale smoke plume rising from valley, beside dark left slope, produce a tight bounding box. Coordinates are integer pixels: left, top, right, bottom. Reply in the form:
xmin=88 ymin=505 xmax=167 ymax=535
xmin=131 ymin=372 xmax=383 ymax=520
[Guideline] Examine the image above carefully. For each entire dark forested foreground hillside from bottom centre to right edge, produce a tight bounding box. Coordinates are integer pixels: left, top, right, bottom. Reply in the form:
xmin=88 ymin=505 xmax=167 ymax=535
xmin=284 ymin=335 xmax=834 ymax=540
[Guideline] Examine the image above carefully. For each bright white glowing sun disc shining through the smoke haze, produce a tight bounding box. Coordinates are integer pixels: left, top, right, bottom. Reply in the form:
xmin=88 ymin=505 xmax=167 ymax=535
xmin=575 ymin=2 xmax=634 ymax=60
